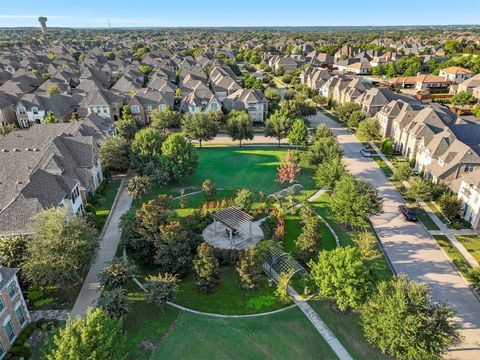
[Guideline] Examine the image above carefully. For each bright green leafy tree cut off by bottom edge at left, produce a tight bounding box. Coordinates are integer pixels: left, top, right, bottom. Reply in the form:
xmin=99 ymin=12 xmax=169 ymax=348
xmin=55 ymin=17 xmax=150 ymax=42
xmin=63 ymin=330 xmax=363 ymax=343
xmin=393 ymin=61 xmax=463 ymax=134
xmin=46 ymin=308 xmax=127 ymax=360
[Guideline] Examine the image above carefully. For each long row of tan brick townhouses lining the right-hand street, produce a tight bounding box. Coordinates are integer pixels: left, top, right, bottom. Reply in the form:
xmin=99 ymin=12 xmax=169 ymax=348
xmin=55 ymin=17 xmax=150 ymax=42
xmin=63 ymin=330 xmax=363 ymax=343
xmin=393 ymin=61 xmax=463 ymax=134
xmin=300 ymin=67 xmax=480 ymax=229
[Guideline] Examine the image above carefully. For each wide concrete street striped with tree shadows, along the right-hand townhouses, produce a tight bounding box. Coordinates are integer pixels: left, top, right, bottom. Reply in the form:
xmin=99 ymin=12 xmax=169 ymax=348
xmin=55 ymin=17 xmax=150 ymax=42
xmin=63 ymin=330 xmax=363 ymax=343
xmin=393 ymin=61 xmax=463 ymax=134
xmin=310 ymin=112 xmax=480 ymax=359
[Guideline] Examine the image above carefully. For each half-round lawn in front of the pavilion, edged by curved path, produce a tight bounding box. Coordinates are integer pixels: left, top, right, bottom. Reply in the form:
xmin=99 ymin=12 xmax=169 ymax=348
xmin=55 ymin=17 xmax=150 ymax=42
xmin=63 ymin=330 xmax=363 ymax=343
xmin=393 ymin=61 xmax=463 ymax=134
xmin=175 ymin=266 xmax=286 ymax=315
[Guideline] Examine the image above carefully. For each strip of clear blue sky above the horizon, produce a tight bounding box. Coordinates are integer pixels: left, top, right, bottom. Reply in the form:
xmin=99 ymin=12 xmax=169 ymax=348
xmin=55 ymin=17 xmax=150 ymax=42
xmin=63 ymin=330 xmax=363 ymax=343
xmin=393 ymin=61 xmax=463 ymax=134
xmin=0 ymin=0 xmax=480 ymax=27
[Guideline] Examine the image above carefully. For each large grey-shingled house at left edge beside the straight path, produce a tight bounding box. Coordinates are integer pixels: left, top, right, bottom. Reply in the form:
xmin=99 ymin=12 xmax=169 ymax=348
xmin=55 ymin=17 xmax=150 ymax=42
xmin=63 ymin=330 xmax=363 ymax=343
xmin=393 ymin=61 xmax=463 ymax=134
xmin=0 ymin=120 xmax=107 ymax=236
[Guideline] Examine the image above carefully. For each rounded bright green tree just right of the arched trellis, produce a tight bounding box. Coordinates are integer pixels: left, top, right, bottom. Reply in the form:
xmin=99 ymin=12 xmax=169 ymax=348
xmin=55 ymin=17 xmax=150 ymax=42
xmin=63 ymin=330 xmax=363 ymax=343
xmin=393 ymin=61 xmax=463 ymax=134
xmin=309 ymin=246 xmax=373 ymax=310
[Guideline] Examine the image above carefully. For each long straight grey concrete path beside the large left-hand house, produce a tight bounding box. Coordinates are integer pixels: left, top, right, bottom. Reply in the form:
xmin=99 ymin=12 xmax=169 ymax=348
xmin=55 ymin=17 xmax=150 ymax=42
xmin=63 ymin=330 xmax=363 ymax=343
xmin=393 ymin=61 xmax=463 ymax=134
xmin=70 ymin=178 xmax=132 ymax=318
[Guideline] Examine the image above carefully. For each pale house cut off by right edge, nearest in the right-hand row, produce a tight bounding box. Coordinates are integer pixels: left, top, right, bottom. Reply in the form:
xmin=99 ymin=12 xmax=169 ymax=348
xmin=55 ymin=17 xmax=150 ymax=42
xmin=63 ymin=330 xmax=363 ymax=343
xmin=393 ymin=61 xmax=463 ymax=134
xmin=450 ymin=168 xmax=480 ymax=230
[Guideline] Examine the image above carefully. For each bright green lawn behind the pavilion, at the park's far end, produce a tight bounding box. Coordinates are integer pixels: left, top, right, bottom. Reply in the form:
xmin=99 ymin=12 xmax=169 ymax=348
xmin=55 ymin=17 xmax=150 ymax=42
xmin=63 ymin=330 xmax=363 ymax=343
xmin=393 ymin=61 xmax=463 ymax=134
xmin=133 ymin=146 xmax=315 ymax=208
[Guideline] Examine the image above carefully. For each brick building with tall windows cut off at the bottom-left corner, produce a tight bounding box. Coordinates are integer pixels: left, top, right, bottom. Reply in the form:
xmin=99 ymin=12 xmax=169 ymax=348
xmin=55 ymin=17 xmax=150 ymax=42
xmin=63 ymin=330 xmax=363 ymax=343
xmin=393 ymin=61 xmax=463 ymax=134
xmin=0 ymin=265 xmax=31 ymax=359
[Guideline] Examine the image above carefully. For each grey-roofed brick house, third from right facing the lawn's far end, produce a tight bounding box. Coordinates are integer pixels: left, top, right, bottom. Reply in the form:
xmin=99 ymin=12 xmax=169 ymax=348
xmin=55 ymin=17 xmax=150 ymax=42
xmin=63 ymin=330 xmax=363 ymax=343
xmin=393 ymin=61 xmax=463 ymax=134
xmin=128 ymin=89 xmax=175 ymax=124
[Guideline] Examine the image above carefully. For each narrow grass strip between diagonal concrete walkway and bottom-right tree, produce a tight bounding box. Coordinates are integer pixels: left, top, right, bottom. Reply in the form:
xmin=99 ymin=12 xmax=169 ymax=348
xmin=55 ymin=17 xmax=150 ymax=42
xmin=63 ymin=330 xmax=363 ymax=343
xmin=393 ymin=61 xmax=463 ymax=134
xmin=308 ymin=300 xmax=389 ymax=360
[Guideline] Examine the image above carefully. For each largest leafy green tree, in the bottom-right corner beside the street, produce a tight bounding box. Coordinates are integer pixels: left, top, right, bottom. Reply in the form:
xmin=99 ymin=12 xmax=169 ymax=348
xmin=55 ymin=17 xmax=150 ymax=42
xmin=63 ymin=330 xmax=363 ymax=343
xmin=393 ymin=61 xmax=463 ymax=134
xmin=361 ymin=275 xmax=460 ymax=360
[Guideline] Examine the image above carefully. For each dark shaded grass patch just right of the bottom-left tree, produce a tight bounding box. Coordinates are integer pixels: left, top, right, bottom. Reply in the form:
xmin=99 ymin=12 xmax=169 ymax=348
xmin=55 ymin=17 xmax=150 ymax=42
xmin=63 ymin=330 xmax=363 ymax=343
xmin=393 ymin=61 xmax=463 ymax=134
xmin=123 ymin=281 xmax=181 ymax=360
